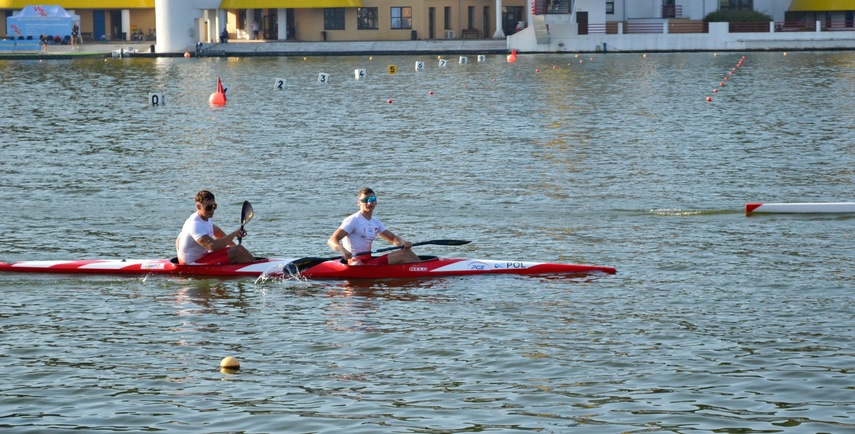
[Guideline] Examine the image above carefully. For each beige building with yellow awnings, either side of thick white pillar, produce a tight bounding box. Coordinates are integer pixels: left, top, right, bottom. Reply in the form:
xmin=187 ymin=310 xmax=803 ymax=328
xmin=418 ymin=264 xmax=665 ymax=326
xmin=0 ymin=0 xmax=528 ymax=42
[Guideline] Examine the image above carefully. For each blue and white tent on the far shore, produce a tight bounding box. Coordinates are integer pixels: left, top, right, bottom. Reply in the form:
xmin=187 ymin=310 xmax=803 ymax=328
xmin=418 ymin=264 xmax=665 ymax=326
xmin=6 ymin=5 xmax=80 ymax=39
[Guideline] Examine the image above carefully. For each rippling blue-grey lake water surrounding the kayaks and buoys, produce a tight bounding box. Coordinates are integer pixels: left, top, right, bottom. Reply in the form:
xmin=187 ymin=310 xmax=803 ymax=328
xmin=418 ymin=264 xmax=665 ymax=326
xmin=0 ymin=52 xmax=855 ymax=433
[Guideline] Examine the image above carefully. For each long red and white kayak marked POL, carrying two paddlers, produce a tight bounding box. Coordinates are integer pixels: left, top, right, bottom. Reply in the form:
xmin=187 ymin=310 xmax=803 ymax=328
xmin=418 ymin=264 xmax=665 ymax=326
xmin=0 ymin=257 xmax=617 ymax=280
